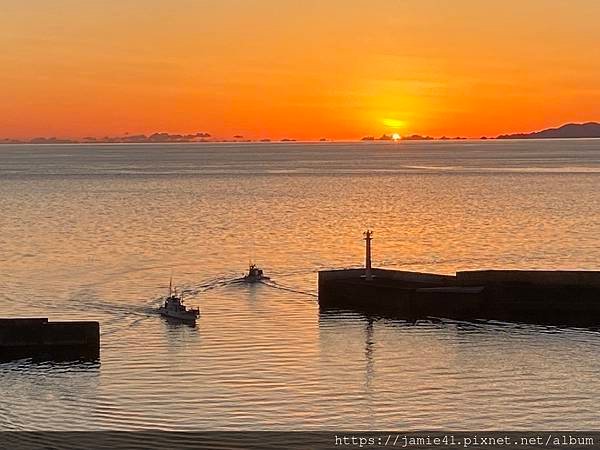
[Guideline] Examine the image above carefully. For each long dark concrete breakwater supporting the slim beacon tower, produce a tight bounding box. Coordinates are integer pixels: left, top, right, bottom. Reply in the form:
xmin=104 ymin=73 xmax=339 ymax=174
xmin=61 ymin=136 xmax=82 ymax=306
xmin=319 ymin=268 xmax=600 ymax=327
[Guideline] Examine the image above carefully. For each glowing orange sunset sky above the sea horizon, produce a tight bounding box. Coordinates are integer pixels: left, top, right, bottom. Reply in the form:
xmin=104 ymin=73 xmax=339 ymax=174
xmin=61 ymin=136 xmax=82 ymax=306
xmin=0 ymin=0 xmax=600 ymax=139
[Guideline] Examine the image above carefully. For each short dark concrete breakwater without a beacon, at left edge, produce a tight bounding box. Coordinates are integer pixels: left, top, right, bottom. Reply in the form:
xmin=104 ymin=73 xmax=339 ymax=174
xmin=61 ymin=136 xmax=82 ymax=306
xmin=0 ymin=318 xmax=100 ymax=361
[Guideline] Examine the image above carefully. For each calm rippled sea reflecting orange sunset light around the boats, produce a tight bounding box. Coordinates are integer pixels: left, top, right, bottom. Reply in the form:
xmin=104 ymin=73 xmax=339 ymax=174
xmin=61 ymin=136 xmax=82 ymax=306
xmin=0 ymin=140 xmax=600 ymax=430
